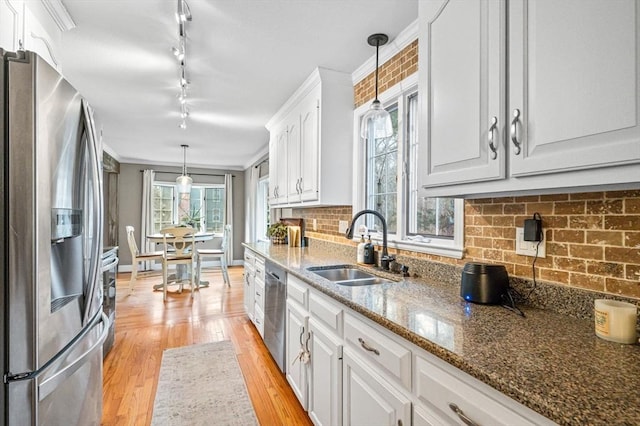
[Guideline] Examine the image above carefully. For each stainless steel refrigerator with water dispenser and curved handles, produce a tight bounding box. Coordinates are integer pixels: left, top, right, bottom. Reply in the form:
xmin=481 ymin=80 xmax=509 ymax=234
xmin=0 ymin=49 xmax=109 ymax=425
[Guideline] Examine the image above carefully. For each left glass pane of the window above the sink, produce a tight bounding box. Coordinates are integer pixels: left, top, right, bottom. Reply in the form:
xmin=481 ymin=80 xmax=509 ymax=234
xmin=366 ymin=104 xmax=398 ymax=233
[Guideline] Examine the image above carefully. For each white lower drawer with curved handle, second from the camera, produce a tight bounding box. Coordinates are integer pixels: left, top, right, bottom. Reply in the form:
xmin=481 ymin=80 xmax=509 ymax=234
xmin=344 ymin=314 xmax=411 ymax=391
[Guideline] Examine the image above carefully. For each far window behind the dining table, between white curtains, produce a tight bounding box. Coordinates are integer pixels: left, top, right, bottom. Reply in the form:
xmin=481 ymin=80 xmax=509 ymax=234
xmin=153 ymin=182 xmax=225 ymax=233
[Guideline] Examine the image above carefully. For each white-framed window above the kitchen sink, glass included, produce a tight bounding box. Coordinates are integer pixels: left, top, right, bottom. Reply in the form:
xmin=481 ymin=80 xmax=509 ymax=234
xmin=353 ymin=75 xmax=464 ymax=258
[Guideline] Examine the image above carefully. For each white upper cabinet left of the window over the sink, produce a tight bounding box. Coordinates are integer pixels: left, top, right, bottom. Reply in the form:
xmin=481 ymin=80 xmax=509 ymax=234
xmin=266 ymin=68 xmax=353 ymax=207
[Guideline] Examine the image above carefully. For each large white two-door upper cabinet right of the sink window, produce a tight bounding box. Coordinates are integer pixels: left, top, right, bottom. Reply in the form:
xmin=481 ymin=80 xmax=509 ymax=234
xmin=419 ymin=0 xmax=640 ymax=196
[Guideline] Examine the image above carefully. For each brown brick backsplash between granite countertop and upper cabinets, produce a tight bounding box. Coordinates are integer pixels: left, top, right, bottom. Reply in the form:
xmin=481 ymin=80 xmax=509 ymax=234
xmin=293 ymin=190 xmax=640 ymax=298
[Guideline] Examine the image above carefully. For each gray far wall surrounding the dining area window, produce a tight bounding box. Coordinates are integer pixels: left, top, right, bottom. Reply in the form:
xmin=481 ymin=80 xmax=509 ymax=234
xmin=118 ymin=163 xmax=245 ymax=266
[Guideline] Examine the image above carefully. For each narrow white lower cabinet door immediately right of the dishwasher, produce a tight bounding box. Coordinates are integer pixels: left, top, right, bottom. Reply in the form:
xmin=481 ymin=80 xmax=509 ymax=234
xmin=285 ymin=301 xmax=309 ymax=410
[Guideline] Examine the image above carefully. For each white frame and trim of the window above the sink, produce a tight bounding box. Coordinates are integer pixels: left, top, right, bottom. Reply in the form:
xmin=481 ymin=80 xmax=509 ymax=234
xmin=352 ymin=73 xmax=464 ymax=259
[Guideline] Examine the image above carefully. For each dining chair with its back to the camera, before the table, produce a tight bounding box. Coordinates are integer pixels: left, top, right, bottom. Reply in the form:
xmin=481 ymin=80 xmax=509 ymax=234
xmin=160 ymin=226 xmax=196 ymax=301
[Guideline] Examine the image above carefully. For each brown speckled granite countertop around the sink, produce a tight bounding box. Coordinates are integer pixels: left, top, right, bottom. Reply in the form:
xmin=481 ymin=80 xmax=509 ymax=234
xmin=245 ymin=243 xmax=640 ymax=425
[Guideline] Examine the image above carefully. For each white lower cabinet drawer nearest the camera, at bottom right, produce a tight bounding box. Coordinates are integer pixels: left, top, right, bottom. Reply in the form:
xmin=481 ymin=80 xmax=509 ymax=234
xmin=415 ymin=355 xmax=554 ymax=426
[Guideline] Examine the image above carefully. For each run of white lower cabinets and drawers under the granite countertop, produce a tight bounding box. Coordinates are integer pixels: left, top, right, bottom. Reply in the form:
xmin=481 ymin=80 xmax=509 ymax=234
xmin=282 ymin=274 xmax=554 ymax=426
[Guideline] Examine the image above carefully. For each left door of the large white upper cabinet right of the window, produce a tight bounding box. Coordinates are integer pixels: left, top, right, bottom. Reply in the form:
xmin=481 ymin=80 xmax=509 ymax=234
xmin=419 ymin=0 xmax=506 ymax=186
